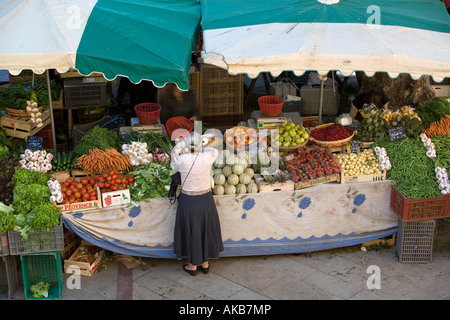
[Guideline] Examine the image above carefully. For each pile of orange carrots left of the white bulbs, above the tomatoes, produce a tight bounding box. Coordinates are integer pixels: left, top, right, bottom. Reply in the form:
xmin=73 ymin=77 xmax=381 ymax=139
xmin=76 ymin=148 xmax=131 ymax=175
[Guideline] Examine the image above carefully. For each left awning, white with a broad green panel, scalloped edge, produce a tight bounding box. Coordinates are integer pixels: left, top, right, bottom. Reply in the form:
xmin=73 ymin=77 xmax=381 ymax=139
xmin=0 ymin=0 xmax=201 ymax=90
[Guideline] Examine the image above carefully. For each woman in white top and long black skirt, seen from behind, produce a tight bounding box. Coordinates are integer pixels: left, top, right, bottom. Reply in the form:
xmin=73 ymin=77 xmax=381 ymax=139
xmin=174 ymin=133 xmax=223 ymax=276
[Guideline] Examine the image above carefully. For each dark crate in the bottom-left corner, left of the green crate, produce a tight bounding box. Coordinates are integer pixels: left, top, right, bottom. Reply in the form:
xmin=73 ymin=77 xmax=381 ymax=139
xmin=0 ymin=256 xmax=19 ymax=299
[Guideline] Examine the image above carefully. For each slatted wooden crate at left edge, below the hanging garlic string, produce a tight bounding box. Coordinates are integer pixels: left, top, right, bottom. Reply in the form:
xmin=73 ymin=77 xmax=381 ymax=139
xmin=0 ymin=110 xmax=51 ymax=139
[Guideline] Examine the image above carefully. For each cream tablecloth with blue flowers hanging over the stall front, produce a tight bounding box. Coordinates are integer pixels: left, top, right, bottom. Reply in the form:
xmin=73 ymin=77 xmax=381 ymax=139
xmin=63 ymin=181 xmax=398 ymax=258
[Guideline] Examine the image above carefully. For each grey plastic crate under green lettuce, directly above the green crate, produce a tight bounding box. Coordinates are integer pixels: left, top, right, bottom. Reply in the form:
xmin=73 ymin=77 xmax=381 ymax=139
xmin=8 ymin=224 xmax=64 ymax=255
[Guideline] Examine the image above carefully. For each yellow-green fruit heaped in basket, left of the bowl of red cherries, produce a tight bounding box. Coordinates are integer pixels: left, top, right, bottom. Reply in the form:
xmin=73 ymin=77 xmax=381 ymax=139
xmin=270 ymin=120 xmax=309 ymax=147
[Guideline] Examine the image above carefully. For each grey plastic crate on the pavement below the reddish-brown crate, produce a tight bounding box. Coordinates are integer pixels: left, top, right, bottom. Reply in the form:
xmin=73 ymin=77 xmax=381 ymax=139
xmin=396 ymin=219 xmax=436 ymax=263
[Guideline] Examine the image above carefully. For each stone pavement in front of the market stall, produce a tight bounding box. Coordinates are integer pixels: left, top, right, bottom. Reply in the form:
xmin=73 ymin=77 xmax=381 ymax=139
xmin=8 ymin=220 xmax=450 ymax=301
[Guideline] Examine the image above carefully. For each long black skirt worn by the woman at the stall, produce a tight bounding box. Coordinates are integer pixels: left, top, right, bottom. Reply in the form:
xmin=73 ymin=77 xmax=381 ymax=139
xmin=174 ymin=192 xmax=223 ymax=266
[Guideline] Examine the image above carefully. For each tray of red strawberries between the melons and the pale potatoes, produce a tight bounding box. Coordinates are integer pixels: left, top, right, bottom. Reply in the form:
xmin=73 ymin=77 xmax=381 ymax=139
xmin=284 ymin=146 xmax=341 ymax=182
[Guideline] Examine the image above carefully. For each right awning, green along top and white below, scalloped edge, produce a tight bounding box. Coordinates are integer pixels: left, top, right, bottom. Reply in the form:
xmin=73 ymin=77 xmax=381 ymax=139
xmin=201 ymin=0 xmax=450 ymax=81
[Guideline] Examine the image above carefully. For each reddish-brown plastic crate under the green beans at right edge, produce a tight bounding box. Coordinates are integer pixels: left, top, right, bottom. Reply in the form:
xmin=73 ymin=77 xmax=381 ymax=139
xmin=391 ymin=186 xmax=450 ymax=221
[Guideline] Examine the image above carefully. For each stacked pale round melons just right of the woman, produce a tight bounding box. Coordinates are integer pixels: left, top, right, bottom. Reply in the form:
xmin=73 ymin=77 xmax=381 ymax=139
xmin=211 ymin=150 xmax=258 ymax=195
